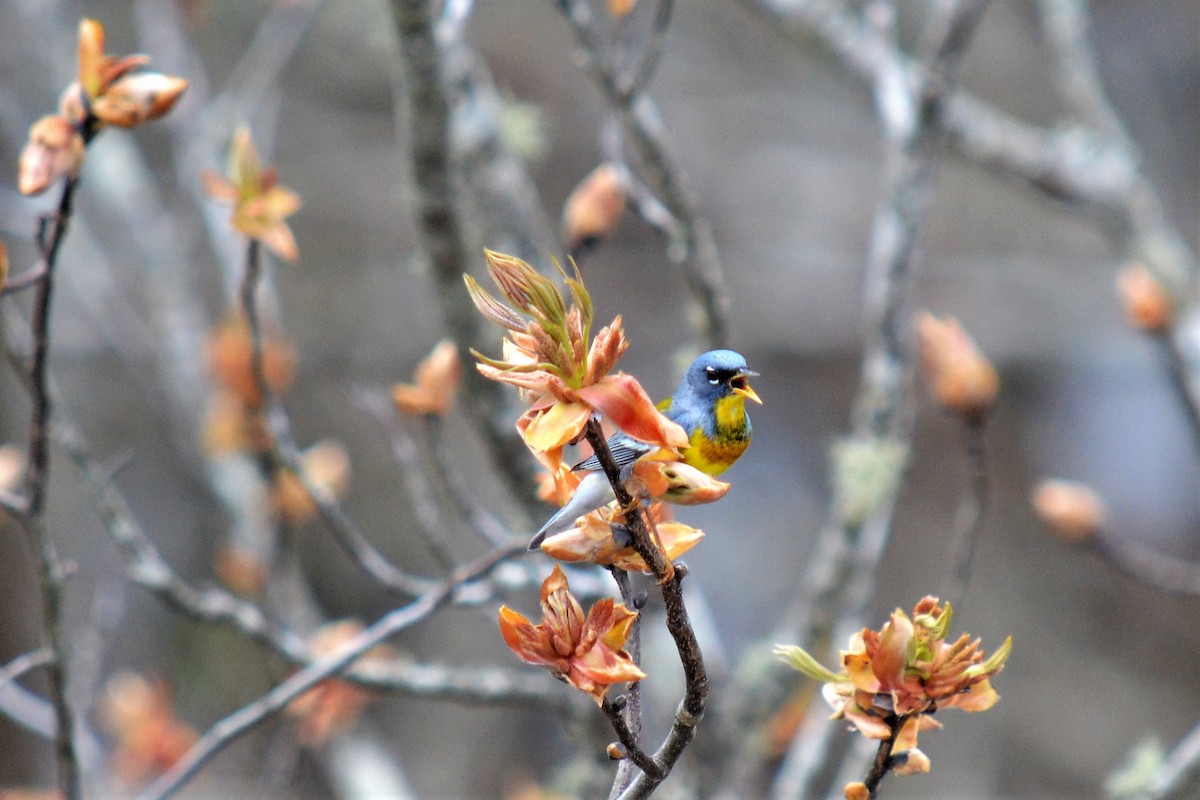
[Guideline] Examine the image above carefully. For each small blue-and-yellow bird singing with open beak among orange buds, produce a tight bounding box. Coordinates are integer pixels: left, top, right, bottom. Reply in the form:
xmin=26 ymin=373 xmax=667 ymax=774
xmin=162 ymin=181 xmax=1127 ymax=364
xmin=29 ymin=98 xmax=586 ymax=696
xmin=529 ymin=350 xmax=762 ymax=551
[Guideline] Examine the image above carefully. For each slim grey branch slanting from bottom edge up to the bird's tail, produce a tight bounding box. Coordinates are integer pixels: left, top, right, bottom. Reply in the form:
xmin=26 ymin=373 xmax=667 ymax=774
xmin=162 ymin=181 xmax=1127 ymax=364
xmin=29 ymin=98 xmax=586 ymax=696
xmin=139 ymin=543 xmax=524 ymax=800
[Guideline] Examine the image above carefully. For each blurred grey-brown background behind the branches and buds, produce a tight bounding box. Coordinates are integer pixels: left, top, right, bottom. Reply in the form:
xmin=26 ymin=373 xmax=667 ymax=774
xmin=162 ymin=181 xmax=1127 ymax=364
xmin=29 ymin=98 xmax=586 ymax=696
xmin=0 ymin=0 xmax=1200 ymax=798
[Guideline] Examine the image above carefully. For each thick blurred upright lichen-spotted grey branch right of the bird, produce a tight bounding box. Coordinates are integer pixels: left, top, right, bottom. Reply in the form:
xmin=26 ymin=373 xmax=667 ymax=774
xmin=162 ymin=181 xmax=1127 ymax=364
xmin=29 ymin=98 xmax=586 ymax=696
xmin=724 ymin=0 xmax=985 ymax=798
